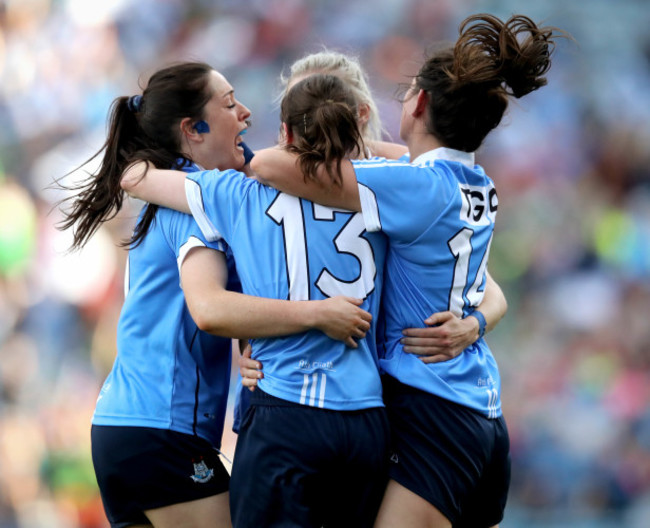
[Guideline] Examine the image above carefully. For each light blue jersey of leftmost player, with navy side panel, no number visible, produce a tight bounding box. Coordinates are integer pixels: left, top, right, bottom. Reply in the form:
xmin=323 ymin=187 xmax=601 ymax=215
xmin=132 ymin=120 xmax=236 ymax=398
xmin=92 ymin=161 xmax=238 ymax=447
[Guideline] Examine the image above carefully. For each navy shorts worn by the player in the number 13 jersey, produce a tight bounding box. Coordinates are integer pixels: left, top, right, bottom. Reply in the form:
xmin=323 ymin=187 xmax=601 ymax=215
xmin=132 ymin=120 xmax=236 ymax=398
xmin=230 ymin=388 xmax=389 ymax=528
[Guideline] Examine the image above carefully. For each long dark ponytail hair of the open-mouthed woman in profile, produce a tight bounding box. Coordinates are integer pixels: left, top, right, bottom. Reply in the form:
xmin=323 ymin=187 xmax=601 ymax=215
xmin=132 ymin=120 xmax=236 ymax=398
xmin=58 ymin=62 xmax=213 ymax=249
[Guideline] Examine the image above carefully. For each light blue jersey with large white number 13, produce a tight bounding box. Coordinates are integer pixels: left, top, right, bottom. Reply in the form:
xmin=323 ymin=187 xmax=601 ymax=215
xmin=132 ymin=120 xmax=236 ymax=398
xmin=186 ymin=170 xmax=386 ymax=410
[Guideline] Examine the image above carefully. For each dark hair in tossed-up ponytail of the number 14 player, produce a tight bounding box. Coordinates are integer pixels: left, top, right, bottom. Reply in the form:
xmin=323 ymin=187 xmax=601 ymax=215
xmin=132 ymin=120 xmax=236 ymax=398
xmin=415 ymin=14 xmax=566 ymax=152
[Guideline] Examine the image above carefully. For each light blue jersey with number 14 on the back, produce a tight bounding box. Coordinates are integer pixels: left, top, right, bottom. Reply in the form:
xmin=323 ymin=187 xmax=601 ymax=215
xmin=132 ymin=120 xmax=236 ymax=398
xmin=353 ymin=148 xmax=501 ymax=418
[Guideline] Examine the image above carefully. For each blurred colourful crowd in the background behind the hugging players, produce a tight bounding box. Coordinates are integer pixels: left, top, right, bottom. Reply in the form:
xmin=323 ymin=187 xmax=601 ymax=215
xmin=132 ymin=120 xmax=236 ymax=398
xmin=0 ymin=0 xmax=650 ymax=528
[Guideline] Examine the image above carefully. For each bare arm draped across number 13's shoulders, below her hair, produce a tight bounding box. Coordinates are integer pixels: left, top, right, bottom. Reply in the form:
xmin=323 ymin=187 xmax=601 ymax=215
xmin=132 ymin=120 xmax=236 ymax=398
xmin=251 ymin=147 xmax=361 ymax=211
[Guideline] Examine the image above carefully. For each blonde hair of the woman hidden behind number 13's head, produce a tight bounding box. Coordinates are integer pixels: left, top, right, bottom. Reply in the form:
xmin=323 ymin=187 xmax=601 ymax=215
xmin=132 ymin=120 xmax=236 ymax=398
xmin=280 ymin=50 xmax=384 ymax=141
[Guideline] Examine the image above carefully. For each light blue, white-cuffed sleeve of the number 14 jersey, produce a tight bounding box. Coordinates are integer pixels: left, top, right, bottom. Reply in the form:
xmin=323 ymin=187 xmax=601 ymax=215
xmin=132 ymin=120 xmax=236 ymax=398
xmin=352 ymin=158 xmax=450 ymax=243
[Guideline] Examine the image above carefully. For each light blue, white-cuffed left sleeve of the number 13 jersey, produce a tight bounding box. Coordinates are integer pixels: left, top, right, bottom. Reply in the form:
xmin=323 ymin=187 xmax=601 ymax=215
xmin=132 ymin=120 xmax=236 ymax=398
xmin=185 ymin=170 xmax=253 ymax=241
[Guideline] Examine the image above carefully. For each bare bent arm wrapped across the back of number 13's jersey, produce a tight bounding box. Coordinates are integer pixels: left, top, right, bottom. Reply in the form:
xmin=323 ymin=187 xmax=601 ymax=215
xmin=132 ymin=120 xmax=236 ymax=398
xmin=181 ymin=248 xmax=372 ymax=348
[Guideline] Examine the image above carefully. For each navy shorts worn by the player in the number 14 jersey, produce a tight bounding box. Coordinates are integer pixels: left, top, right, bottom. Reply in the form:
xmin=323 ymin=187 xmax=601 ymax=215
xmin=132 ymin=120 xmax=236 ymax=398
xmin=383 ymin=376 xmax=510 ymax=528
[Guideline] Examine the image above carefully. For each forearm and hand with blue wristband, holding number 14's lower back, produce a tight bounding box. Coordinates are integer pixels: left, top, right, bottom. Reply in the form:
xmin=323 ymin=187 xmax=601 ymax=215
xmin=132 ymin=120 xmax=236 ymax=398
xmin=401 ymin=273 xmax=508 ymax=363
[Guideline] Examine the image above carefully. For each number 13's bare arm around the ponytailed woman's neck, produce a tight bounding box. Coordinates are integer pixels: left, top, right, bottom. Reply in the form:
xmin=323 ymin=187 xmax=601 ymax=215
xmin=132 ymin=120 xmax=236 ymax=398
xmin=120 ymin=161 xmax=191 ymax=214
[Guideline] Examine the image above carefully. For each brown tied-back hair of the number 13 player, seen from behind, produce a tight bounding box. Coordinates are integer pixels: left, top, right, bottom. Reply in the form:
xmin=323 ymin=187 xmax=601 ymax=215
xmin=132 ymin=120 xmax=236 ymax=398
xmin=280 ymin=74 xmax=365 ymax=185
